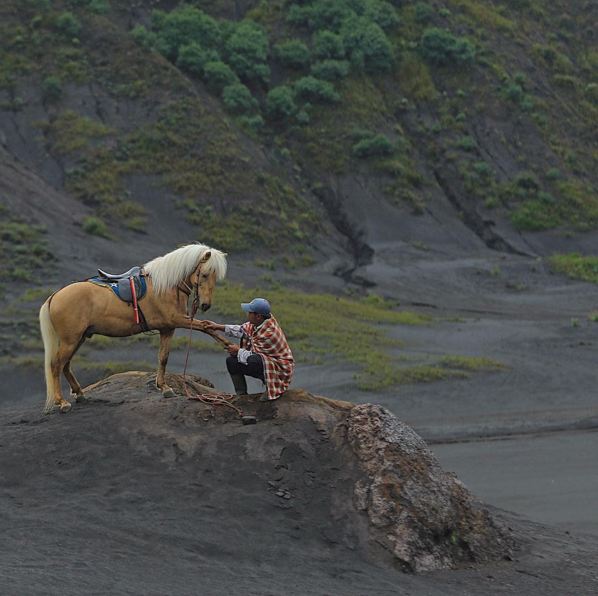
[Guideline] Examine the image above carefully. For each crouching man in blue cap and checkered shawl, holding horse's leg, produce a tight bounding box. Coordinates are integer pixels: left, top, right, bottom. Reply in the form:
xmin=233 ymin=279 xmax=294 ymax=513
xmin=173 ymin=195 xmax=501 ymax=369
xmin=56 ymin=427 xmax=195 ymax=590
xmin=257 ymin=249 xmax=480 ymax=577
xmin=203 ymin=298 xmax=295 ymax=401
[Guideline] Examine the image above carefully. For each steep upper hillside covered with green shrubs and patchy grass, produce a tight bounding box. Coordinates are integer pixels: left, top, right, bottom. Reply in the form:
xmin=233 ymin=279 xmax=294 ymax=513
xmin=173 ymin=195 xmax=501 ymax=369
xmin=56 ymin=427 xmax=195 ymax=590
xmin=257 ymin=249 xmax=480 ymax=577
xmin=0 ymin=0 xmax=598 ymax=244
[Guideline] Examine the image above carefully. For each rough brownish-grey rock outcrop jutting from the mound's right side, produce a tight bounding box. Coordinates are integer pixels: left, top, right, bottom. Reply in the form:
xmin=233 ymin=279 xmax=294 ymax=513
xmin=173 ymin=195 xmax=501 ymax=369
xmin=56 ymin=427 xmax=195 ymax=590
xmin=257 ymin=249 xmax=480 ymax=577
xmin=347 ymin=404 xmax=513 ymax=571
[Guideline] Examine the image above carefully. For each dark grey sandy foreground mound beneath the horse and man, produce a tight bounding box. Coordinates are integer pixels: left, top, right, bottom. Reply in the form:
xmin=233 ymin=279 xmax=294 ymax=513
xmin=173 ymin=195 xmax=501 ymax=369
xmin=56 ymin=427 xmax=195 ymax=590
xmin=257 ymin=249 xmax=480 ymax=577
xmin=0 ymin=386 xmax=598 ymax=596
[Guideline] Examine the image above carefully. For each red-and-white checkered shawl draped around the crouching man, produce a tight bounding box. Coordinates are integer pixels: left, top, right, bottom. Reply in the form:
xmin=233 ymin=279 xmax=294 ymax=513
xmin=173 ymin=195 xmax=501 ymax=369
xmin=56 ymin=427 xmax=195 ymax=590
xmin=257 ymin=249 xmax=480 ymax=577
xmin=241 ymin=317 xmax=295 ymax=399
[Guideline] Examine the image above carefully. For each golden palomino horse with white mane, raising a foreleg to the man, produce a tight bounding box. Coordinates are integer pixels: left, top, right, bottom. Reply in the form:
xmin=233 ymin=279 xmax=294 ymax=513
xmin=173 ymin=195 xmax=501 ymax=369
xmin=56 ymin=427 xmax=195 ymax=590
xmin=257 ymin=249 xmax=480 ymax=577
xmin=39 ymin=244 xmax=226 ymax=412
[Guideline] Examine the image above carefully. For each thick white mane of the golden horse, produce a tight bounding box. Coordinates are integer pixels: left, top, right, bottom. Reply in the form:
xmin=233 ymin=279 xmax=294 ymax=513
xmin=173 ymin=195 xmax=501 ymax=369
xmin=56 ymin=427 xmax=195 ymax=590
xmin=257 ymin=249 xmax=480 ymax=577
xmin=143 ymin=244 xmax=226 ymax=294
